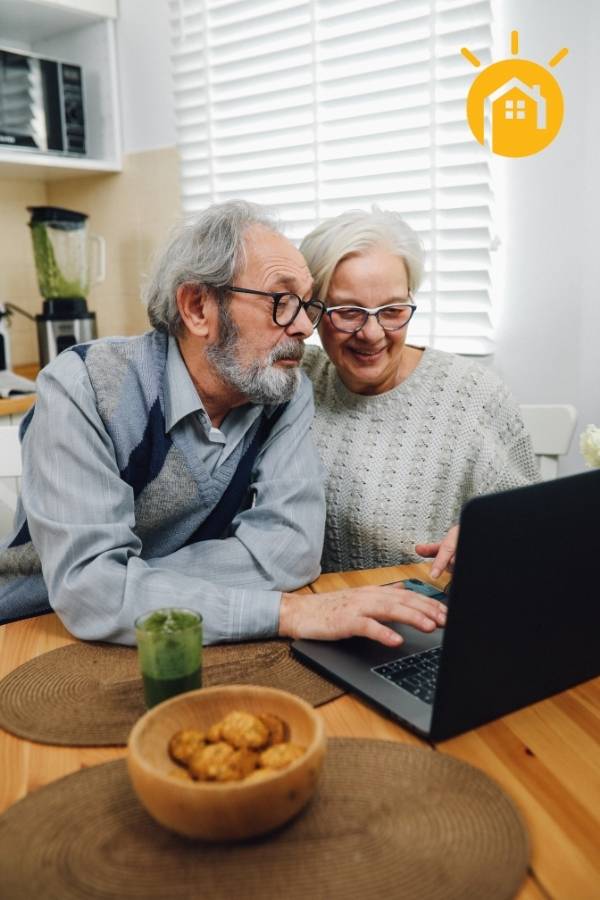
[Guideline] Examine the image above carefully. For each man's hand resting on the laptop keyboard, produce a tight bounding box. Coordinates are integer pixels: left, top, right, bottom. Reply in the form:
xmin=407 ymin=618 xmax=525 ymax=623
xmin=279 ymin=586 xmax=446 ymax=647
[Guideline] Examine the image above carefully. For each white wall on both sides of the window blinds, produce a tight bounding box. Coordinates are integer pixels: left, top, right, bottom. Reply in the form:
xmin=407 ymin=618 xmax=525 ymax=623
xmin=118 ymin=0 xmax=600 ymax=474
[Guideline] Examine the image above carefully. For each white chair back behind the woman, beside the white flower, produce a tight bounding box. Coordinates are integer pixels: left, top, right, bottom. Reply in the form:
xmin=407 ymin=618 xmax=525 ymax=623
xmin=520 ymin=403 xmax=577 ymax=481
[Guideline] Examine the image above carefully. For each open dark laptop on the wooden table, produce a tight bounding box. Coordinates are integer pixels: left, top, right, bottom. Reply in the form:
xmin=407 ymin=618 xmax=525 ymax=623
xmin=292 ymin=470 xmax=600 ymax=741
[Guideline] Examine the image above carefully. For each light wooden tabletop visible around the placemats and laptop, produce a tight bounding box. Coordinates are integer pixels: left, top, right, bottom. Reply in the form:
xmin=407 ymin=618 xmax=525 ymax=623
xmin=0 ymin=565 xmax=600 ymax=900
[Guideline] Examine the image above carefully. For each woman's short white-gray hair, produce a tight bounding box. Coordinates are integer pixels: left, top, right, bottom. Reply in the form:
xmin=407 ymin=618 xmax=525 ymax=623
xmin=300 ymin=206 xmax=425 ymax=299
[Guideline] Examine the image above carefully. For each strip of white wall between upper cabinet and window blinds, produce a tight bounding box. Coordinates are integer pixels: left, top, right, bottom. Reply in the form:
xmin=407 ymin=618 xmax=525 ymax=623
xmin=117 ymin=0 xmax=176 ymax=153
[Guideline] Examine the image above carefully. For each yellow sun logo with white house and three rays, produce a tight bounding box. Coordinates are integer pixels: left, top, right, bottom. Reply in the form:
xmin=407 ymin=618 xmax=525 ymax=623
xmin=460 ymin=31 xmax=569 ymax=156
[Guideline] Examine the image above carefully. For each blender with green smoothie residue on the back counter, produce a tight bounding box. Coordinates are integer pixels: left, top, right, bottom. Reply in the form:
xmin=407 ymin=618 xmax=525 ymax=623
xmin=27 ymin=206 xmax=105 ymax=367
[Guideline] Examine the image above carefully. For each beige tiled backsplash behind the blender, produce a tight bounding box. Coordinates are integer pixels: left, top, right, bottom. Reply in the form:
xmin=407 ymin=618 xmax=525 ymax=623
xmin=0 ymin=147 xmax=181 ymax=365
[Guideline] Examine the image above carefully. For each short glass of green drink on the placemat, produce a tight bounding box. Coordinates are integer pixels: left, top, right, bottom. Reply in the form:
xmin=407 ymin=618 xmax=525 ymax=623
xmin=135 ymin=607 xmax=202 ymax=709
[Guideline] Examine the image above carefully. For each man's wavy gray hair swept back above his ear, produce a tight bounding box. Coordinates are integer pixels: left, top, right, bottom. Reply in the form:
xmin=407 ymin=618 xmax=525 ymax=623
xmin=142 ymin=200 xmax=281 ymax=336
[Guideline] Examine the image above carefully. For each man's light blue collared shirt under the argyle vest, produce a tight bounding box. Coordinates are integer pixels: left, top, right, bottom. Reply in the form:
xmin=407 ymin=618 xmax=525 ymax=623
xmin=22 ymin=341 xmax=325 ymax=644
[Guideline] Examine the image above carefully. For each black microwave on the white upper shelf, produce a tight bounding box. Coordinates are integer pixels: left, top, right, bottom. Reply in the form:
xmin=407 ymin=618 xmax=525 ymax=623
xmin=0 ymin=48 xmax=86 ymax=155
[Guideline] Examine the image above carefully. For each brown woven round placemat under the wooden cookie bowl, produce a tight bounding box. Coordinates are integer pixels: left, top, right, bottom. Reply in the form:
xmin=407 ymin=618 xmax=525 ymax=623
xmin=0 ymin=738 xmax=529 ymax=900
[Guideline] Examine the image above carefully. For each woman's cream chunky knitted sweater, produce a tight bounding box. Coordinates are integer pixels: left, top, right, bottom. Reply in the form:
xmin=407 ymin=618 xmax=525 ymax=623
xmin=303 ymin=347 xmax=539 ymax=572
